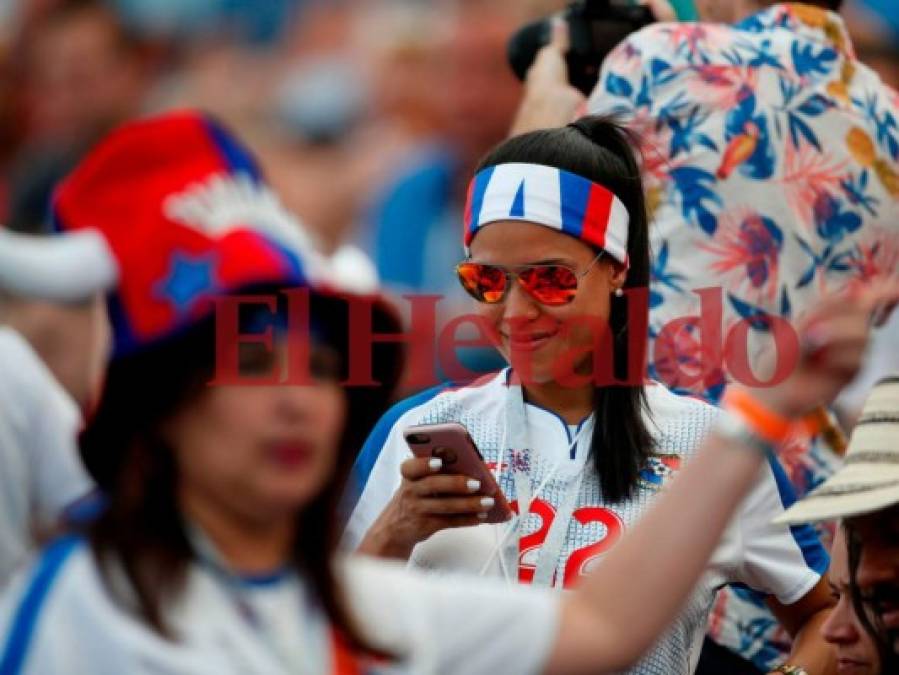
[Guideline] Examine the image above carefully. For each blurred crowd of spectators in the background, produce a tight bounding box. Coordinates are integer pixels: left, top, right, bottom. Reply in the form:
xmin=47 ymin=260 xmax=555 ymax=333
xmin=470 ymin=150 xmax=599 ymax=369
xmin=0 ymin=0 xmax=899 ymax=296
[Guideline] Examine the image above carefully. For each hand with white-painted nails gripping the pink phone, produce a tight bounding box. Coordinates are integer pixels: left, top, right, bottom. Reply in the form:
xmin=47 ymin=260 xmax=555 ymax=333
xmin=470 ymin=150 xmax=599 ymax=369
xmin=359 ymin=457 xmax=512 ymax=560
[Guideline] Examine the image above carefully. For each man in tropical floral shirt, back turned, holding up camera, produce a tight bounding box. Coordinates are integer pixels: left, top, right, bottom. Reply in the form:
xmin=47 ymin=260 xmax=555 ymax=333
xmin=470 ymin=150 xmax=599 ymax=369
xmin=515 ymin=0 xmax=899 ymax=672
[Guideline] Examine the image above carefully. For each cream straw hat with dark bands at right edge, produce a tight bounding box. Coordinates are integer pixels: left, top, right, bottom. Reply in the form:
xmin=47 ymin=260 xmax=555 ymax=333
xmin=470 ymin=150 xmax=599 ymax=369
xmin=774 ymin=374 xmax=899 ymax=524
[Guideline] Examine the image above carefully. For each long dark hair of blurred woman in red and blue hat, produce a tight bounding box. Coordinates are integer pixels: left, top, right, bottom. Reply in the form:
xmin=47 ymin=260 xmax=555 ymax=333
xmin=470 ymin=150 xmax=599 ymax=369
xmin=80 ymin=296 xmax=400 ymax=653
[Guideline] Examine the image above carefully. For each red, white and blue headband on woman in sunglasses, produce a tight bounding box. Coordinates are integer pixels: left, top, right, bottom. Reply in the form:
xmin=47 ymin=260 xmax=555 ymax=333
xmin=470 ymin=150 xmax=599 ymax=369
xmin=464 ymin=163 xmax=630 ymax=266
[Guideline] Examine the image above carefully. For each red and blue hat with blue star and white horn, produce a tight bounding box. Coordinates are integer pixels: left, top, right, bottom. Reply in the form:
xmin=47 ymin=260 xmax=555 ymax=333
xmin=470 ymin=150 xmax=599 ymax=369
xmin=0 ymin=112 xmax=324 ymax=356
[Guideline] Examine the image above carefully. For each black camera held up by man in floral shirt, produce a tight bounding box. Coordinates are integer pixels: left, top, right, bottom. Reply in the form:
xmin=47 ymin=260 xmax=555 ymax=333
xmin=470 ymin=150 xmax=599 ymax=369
xmin=508 ymin=0 xmax=655 ymax=96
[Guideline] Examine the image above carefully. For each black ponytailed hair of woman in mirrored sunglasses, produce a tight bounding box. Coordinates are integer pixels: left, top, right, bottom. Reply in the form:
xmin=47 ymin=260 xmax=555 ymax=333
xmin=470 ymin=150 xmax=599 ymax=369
xmin=477 ymin=116 xmax=653 ymax=501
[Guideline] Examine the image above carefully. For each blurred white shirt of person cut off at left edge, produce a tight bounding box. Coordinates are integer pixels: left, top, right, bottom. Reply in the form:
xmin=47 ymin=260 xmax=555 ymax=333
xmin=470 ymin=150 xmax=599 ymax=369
xmin=0 ymin=327 xmax=92 ymax=588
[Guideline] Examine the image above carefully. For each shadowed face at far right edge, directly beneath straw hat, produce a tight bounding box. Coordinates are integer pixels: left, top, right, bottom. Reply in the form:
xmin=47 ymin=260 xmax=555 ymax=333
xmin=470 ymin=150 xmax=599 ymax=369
xmin=850 ymin=505 xmax=899 ymax=651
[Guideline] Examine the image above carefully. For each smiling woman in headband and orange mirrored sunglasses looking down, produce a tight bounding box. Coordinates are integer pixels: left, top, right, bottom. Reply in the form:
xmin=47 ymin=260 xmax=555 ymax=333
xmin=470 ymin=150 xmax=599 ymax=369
xmin=344 ymin=117 xmax=844 ymax=675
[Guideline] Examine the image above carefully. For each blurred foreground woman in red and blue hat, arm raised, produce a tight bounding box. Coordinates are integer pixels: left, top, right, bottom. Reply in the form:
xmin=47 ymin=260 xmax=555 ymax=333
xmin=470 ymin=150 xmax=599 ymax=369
xmin=0 ymin=113 xmax=899 ymax=675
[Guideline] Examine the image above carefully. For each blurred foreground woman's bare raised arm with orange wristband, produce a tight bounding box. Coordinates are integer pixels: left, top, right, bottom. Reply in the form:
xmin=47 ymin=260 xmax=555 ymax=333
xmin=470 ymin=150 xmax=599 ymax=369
xmin=547 ymin=285 xmax=899 ymax=674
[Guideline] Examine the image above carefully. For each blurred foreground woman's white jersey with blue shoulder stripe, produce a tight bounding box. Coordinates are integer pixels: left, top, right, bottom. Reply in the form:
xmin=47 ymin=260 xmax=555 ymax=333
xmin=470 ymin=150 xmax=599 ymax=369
xmin=0 ymin=537 xmax=559 ymax=675
